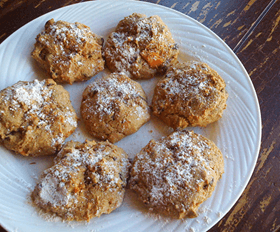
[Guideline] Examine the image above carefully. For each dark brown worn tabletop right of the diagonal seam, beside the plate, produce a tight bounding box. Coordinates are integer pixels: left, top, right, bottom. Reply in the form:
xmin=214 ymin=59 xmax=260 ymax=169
xmin=210 ymin=0 xmax=280 ymax=232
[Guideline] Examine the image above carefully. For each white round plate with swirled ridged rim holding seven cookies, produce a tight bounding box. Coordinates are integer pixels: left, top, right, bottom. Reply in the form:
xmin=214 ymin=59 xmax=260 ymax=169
xmin=0 ymin=0 xmax=261 ymax=232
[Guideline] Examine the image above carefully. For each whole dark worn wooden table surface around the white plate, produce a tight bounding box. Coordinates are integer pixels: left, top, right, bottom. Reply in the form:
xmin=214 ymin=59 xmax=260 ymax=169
xmin=0 ymin=0 xmax=280 ymax=232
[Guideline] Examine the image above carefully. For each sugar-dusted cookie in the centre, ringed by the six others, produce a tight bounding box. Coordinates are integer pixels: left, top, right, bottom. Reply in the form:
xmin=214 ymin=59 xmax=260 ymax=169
xmin=81 ymin=73 xmax=150 ymax=143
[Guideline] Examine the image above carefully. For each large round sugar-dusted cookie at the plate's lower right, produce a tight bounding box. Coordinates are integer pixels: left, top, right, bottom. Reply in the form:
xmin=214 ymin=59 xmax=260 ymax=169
xmin=129 ymin=130 xmax=224 ymax=218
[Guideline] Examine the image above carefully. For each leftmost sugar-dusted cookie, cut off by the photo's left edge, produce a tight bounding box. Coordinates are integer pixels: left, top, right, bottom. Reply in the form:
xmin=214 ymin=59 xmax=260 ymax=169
xmin=0 ymin=79 xmax=77 ymax=156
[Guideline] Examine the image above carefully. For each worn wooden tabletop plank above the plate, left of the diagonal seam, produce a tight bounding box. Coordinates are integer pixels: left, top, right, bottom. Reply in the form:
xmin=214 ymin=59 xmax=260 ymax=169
xmin=144 ymin=0 xmax=270 ymax=49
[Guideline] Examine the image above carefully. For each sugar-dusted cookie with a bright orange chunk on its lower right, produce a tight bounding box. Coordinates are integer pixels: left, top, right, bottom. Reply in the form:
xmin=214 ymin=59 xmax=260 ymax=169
xmin=104 ymin=13 xmax=179 ymax=79
